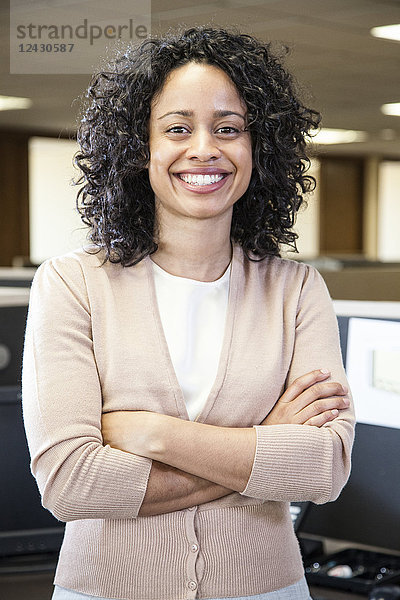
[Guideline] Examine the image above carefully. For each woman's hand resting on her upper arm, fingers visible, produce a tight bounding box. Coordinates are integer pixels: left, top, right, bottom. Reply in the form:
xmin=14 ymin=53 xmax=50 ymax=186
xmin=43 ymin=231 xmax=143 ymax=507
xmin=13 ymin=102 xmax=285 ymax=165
xmin=261 ymin=370 xmax=350 ymax=427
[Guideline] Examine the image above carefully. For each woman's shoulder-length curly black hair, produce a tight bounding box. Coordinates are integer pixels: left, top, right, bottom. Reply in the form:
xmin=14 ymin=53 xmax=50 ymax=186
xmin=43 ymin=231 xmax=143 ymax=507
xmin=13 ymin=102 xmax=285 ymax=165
xmin=75 ymin=27 xmax=320 ymax=266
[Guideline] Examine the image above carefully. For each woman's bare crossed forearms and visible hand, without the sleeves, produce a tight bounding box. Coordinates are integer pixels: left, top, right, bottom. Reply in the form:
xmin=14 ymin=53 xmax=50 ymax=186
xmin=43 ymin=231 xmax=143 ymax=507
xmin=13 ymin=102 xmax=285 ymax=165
xmin=102 ymin=370 xmax=350 ymax=516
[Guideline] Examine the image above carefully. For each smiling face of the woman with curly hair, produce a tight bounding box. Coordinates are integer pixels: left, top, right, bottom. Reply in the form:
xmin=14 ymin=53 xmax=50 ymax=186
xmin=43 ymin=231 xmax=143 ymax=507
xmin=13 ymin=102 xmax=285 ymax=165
xmin=148 ymin=63 xmax=252 ymax=221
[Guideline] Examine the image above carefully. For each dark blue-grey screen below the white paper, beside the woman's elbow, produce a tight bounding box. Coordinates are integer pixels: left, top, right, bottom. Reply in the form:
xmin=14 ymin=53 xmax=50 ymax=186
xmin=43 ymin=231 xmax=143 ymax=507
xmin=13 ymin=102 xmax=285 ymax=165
xmin=300 ymin=423 xmax=400 ymax=551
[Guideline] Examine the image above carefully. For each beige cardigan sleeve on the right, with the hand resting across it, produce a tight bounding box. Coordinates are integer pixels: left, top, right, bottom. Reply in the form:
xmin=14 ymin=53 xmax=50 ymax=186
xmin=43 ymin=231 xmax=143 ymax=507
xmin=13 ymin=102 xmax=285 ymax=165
xmin=242 ymin=266 xmax=355 ymax=504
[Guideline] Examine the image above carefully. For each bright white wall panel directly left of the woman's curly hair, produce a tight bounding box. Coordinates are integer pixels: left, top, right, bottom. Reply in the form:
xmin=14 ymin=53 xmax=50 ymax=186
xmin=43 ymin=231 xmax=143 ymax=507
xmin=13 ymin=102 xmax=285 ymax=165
xmin=29 ymin=137 xmax=87 ymax=263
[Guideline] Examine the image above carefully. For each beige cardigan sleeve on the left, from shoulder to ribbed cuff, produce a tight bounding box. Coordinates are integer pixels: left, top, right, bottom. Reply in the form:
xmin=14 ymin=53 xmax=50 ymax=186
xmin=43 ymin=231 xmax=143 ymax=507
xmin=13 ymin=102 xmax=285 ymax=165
xmin=22 ymin=258 xmax=151 ymax=521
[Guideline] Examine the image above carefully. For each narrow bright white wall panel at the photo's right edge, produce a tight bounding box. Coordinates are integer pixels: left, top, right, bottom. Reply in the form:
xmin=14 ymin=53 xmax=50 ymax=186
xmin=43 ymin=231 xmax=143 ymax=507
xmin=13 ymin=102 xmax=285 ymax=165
xmin=378 ymin=161 xmax=400 ymax=261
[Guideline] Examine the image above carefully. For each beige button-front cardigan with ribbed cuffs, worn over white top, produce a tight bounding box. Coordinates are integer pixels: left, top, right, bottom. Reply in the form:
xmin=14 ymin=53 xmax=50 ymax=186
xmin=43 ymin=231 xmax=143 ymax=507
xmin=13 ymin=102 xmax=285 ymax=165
xmin=23 ymin=246 xmax=354 ymax=600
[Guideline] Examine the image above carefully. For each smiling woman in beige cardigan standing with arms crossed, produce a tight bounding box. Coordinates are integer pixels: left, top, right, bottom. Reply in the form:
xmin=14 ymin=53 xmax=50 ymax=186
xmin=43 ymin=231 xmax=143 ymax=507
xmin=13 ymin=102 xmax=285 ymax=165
xmin=23 ymin=28 xmax=354 ymax=600
